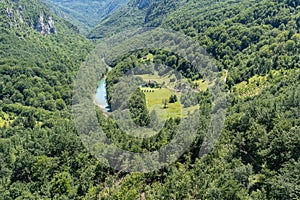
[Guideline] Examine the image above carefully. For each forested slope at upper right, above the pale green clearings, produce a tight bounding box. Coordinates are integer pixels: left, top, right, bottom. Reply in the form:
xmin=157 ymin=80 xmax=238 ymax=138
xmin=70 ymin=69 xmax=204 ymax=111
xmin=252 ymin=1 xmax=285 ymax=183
xmin=163 ymin=0 xmax=300 ymax=85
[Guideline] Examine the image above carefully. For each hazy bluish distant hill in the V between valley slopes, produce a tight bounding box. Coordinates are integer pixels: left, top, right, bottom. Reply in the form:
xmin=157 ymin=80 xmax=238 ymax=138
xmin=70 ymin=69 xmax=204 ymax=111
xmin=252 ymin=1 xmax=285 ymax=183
xmin=42 ymin=0 xmax=128 ymax=33
